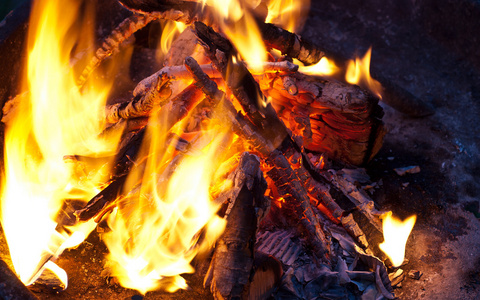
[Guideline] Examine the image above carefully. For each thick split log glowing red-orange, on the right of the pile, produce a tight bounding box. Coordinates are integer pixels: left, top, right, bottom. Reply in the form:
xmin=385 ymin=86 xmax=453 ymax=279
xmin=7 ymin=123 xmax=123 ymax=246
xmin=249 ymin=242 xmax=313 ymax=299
xmin=260 ymin=73 xmax=386 ymax=165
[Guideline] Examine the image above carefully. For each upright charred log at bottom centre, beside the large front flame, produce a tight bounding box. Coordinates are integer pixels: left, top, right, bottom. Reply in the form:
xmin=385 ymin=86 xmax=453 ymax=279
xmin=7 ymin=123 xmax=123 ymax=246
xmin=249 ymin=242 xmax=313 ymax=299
xmin=204 ymin=153 xmax=267 ymax=299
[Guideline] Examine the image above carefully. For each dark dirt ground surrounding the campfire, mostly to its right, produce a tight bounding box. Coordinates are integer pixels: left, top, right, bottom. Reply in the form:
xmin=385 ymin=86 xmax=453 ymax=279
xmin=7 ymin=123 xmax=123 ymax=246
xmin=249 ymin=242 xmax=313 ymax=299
xmin=0 ymin=0 xmax=480 ymax=299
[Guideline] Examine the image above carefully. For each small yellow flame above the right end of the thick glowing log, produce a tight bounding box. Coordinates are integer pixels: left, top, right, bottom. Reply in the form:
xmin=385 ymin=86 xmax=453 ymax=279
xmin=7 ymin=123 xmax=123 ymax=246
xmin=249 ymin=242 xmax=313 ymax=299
xmin=345 ymin=47 xmax=382 ymax=98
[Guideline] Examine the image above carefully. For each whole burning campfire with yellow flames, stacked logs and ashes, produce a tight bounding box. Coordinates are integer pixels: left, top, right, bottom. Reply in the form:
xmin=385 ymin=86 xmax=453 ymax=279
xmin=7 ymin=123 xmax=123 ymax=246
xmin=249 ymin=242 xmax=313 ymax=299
xmin=0 ymin=0 xmax=415 ymax=299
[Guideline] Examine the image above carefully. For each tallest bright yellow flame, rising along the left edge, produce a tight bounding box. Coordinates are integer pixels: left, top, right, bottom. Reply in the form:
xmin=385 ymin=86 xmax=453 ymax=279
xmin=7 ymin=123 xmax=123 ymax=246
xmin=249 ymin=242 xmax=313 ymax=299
xmin=1 ymin=0 xmax=124 ymax=284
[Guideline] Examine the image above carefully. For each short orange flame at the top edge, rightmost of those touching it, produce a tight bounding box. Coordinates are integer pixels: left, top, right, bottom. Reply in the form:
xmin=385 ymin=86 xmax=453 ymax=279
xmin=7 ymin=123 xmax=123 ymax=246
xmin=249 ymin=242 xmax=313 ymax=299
xmin=265 ymin=0 xmax=310 ymax=32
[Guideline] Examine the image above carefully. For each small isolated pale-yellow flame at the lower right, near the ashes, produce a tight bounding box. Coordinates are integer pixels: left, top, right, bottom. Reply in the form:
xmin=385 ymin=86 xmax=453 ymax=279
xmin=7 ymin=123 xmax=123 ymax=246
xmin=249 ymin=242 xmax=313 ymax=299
xmin=379 ymin=211 xmax=417 ymax=267
